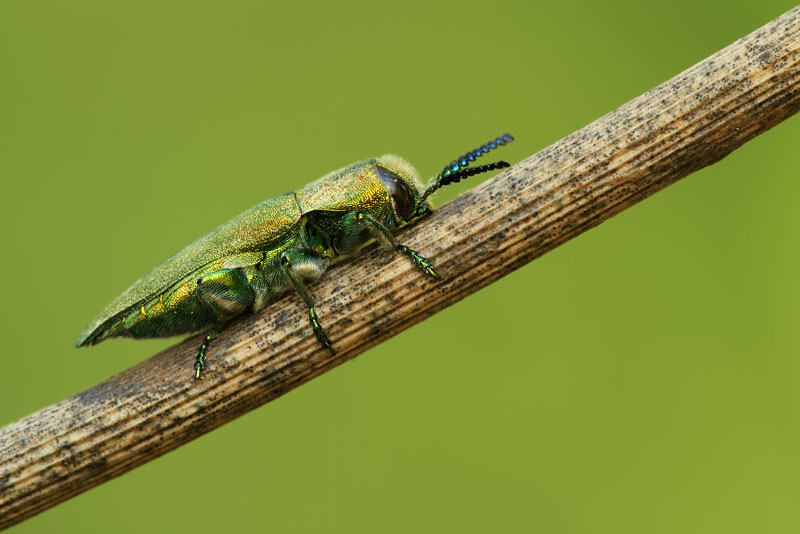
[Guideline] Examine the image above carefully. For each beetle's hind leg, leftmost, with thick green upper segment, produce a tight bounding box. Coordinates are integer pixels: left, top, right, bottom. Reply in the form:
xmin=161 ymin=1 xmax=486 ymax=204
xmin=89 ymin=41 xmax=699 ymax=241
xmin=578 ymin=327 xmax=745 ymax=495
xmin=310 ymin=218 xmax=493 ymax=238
xmin=194 ymin=269 xmax=255 ymax=379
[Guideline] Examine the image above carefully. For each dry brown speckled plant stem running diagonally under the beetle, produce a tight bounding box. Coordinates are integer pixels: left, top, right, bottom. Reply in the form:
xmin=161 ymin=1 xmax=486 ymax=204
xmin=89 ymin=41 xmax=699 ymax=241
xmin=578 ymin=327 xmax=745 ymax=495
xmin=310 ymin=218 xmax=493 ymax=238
xmin=0 ymin=9 xmax=800 ymax=525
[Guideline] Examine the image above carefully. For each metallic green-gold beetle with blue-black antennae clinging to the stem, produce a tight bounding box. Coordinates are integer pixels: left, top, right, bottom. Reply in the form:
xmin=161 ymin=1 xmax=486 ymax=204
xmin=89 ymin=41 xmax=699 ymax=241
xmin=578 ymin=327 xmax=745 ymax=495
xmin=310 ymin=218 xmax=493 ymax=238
xmin=75 ymin=134 xmax=513 ymax=378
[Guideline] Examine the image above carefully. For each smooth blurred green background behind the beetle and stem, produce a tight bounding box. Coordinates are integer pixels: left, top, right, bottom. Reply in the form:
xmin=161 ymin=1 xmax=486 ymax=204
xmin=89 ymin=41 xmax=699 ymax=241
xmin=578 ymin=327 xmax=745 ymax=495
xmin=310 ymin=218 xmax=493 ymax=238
xmin=0 ymin=0 xmax=800 ymax=533
